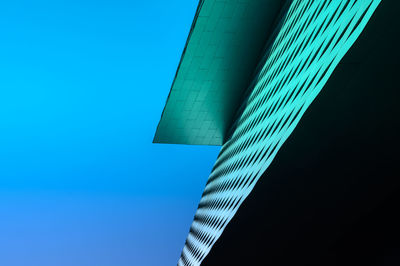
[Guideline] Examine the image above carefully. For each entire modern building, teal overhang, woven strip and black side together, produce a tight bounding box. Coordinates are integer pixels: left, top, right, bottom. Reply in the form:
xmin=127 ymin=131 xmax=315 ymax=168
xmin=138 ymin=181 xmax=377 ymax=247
xmin=154 ymin=0 xmax=400 ymax=265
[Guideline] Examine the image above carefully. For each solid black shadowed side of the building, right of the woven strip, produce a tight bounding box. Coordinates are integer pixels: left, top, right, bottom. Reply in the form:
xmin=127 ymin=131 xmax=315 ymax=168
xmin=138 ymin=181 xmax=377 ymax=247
xmin=202 ymin=0 xmax=400 ymax=266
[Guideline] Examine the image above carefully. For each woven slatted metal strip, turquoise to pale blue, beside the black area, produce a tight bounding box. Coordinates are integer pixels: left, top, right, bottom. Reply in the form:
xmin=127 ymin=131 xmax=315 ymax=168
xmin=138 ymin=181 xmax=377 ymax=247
xmin=178 ymin=0 xmax=380 ymax=265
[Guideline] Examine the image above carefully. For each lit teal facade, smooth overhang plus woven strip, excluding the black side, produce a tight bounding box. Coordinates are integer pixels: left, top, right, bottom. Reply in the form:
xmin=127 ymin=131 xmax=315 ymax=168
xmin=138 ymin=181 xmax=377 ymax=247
xmin=154 ymin=0 xmax=400 ymax=265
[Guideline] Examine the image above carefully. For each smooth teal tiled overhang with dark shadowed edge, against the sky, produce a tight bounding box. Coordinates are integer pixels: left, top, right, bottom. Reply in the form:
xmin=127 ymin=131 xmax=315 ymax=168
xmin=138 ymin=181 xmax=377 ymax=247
xmin=154 ymin=0 xmax=285 ymax=145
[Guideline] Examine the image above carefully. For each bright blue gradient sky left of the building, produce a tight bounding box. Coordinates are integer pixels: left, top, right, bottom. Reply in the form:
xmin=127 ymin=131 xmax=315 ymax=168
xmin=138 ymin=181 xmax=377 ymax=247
xmin=0 ymin=0 xmax=219 ymax=266
